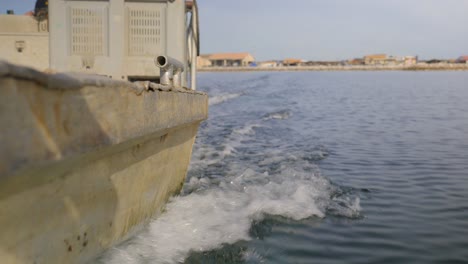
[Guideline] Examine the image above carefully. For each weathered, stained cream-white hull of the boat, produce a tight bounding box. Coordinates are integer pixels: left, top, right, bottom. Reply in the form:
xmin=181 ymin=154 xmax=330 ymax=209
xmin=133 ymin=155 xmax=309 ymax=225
xmin=0 ymin=64 xmax=207 ymax=264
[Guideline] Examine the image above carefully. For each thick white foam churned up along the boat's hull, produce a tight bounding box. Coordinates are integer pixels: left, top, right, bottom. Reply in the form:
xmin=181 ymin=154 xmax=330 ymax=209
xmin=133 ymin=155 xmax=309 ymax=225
xmin=104 ymin=166 xmax=333 ymax=263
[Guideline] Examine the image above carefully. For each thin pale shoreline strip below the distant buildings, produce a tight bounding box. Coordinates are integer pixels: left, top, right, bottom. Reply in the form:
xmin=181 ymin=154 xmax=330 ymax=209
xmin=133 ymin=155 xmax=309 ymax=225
xmin=197 ymin=64 xmax=468 ymax=72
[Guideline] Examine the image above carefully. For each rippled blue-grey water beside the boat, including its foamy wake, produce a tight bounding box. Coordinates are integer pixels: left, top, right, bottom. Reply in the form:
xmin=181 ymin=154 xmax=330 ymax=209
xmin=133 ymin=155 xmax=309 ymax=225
xmin=105 ymin=72 xmax=468 ymax=263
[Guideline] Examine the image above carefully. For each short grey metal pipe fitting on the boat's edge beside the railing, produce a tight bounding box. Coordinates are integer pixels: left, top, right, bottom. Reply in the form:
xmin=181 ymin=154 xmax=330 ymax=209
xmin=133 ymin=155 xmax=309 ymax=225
xmin=154 ymin=56 xmax=184 ymax=87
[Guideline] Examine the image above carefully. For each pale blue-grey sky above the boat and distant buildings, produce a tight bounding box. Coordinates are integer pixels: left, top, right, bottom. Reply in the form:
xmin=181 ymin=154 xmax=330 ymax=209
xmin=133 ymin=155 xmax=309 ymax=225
xmin=0 ymin=0 xmax=468 ymax=61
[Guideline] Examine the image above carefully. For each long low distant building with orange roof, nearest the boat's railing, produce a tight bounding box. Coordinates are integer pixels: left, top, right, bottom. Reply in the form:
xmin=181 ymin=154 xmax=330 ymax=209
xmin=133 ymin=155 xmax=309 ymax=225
xmin=198 ymin=52 xmax=255 ymax=67
